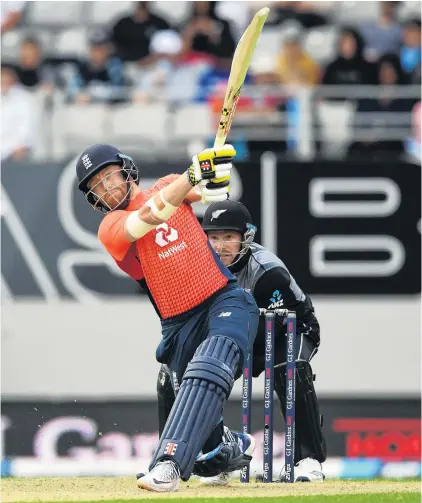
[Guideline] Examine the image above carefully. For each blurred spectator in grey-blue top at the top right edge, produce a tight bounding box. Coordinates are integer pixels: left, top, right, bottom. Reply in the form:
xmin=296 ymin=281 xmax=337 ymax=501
xmin=360 ymin=2 xmax=402 ymax=61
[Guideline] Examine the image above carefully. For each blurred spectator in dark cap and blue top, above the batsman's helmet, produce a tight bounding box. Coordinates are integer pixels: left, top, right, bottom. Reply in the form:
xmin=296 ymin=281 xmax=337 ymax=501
xmin=67 ymin=32 xmax=127 ymax=103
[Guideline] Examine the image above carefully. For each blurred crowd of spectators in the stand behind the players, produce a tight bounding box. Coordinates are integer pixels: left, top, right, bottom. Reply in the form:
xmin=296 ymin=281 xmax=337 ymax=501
xmin=1 ymin=1 xmax=421 ymax=159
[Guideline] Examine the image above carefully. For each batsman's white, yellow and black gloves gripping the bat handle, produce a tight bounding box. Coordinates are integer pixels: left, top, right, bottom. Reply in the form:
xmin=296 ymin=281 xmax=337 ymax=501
xmin=187 ymin=145 xmax=236 ymax=204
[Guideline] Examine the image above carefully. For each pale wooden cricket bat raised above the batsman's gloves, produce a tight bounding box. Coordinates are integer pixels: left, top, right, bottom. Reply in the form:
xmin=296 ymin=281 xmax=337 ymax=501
xmin=214 ymin=7 xmax=270 ymax=147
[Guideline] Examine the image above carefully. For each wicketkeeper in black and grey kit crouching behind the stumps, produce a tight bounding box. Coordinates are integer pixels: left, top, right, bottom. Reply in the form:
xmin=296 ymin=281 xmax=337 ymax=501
xmin=157 ymin=200 xmax=327 ymax=485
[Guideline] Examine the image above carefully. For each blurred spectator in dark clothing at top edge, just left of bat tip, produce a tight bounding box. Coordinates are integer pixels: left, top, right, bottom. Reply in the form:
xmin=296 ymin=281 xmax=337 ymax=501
xmin=182 ymin=1 xmax=236 ymax=59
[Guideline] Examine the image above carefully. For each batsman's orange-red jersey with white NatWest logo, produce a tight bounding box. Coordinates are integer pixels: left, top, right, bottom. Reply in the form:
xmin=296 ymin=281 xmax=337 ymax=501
xmin=98 ymin=175 xmax=235 ymax=319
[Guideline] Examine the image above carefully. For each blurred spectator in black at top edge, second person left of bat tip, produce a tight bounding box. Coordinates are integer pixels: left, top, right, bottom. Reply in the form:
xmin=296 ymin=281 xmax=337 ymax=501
xmin=112 ymin=2 xmax=170 ymax=64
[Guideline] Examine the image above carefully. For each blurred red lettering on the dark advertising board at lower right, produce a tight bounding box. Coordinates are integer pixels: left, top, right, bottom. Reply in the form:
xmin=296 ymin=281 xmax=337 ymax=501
xmin=333 ymin=418 xmax=421 ymax=461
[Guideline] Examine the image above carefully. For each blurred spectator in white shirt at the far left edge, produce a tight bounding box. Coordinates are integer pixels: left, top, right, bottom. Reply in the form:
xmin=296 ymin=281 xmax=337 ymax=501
xmin=0 ymin=65 xmax=36 ymax=161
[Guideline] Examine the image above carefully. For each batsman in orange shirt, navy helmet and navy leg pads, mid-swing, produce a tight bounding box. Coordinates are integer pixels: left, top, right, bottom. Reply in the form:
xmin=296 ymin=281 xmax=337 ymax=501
xmin=76 ymin=145 xmax=259 ymax=492
